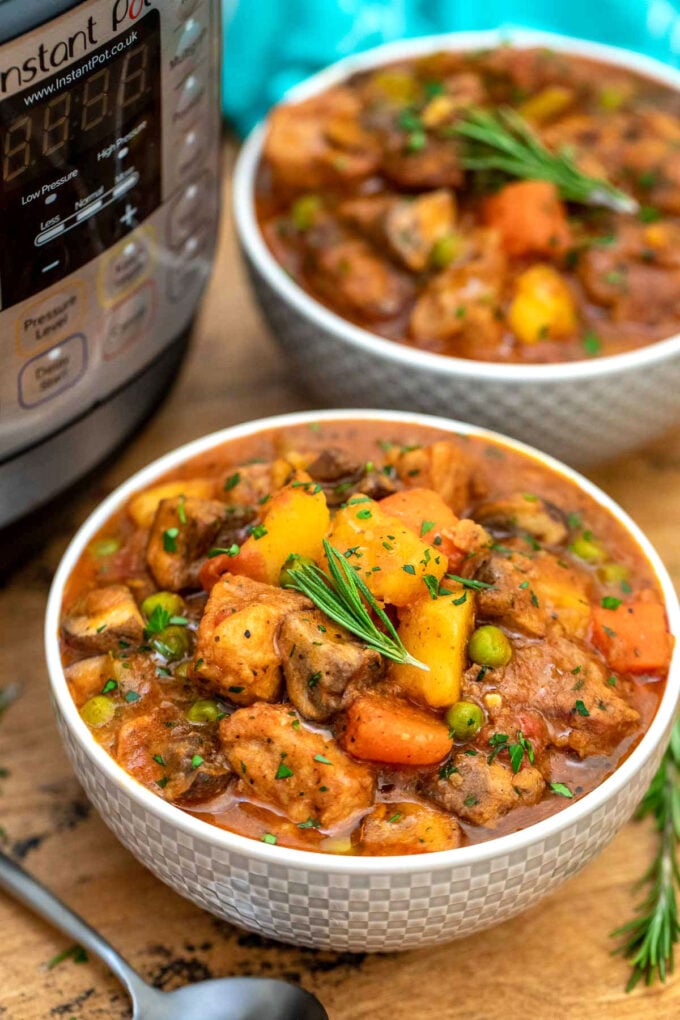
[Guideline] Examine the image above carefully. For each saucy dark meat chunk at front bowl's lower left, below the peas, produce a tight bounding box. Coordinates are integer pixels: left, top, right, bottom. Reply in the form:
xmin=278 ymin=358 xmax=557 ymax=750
xmin=115 ymin=705 xmax=232 ymax=807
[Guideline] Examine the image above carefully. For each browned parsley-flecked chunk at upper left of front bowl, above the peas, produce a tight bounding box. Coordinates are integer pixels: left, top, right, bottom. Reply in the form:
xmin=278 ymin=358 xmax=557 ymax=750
xmin=147 ymin=496 xmax=225 ymax=592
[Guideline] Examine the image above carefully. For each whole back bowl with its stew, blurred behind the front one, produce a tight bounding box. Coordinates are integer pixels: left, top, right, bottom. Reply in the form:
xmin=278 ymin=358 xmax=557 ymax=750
xmin=233 ymin=32 xmax=680 ymax=463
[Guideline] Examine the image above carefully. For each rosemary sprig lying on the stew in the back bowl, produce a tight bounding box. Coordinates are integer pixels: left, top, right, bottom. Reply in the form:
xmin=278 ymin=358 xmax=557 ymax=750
xmin=452 ymin=107 xmax=639 ymax=213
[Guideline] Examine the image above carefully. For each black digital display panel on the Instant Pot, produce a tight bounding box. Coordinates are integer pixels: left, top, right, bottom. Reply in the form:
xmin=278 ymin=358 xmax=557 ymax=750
xmin=0 ymin=10 xmax=161 ymax=308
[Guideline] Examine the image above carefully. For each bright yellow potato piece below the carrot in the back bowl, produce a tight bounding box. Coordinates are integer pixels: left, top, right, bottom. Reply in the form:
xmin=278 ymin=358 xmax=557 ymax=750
xmin=508 ymin=263 xmax=578 ymax=344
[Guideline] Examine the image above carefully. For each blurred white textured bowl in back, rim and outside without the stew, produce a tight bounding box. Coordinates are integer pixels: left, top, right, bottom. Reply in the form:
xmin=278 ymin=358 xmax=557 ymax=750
xmin=233 ymin=31 xmax=680 ymax=464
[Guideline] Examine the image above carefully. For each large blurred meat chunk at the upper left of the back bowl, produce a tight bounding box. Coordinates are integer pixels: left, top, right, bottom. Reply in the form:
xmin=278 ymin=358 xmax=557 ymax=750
xmin=264 ymin=86 xmax=379 ymax=190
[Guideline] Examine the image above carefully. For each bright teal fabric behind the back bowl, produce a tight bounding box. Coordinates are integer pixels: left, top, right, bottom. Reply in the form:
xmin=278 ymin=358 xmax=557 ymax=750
xmin=223 ymin=0 xmax=680 ymax=134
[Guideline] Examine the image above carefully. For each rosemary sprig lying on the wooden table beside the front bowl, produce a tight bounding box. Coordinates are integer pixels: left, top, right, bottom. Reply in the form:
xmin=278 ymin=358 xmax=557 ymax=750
xmin=612 ymin=719 xmax=680 ymax=991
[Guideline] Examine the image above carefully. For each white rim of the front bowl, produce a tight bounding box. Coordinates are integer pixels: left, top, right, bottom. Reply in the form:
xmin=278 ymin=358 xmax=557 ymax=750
xmin=45 ymin=409 xmax=680 ymax=875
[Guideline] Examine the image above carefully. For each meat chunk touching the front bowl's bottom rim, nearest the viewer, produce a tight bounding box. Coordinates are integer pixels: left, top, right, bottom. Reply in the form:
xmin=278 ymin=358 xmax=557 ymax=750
xmin=359 ymin=802 xmax=461 ymax=857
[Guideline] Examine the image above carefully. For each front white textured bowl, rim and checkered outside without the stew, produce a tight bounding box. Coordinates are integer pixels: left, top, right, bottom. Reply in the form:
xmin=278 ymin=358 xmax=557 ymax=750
xmin=45 ymin=411 xmax=680 ymax=951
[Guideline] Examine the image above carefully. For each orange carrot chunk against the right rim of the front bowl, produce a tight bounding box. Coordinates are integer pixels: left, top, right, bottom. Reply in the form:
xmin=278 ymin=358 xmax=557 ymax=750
xmin=592 ymin=602 xmax=673 ymax=673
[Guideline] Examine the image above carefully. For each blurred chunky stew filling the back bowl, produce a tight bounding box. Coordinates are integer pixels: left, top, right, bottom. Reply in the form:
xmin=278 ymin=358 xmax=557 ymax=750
xmin=257 ymin=46 xmax=680 ymax=363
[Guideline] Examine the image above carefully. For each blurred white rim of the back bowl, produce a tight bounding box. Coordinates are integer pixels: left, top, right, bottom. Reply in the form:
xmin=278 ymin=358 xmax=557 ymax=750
xmin=232 ymin=28 xmax=680 ymax=384
